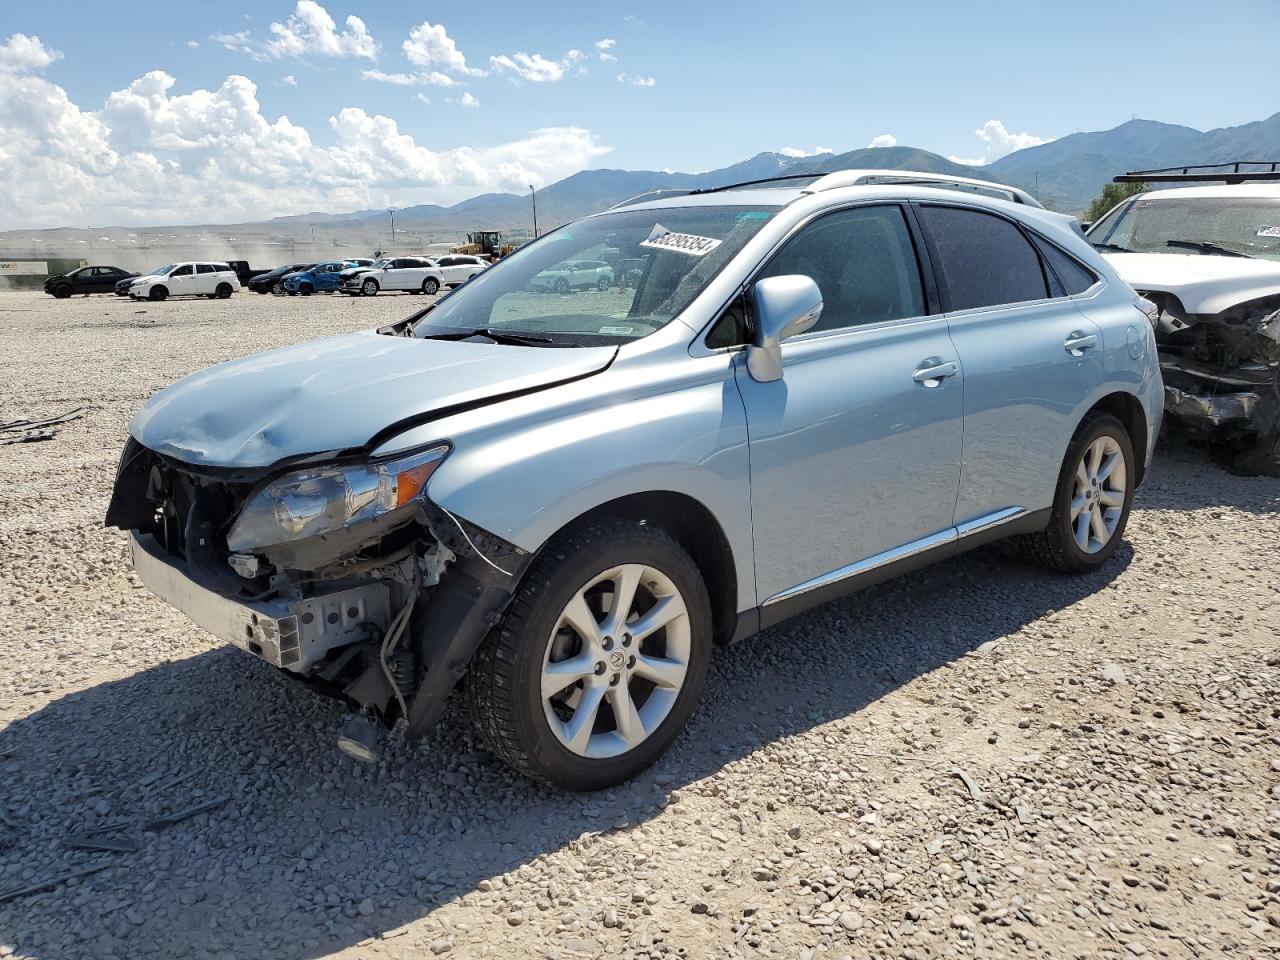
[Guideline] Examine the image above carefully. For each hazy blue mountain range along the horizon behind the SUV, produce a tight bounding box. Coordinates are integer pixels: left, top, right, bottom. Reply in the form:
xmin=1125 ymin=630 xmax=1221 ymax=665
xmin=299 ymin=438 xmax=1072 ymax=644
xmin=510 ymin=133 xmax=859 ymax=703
xmin=270 ymin=113 xmax=1280 ymax=233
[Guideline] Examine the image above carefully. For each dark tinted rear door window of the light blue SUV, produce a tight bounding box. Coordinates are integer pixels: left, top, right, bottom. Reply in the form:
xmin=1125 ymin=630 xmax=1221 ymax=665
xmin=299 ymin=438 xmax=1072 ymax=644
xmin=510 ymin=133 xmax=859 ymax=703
xmin=918 ymin=204 xmax=1048 ymax=310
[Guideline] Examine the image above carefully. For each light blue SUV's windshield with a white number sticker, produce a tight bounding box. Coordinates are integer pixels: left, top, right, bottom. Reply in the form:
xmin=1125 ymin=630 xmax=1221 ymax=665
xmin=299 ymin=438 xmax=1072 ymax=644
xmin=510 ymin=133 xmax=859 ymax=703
xmin=413 ymin=206 xmax=777 ymax=346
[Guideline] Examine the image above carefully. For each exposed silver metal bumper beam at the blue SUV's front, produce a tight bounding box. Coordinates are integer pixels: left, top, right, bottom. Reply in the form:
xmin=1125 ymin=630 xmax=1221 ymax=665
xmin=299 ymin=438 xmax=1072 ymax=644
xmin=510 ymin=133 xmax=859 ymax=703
xmin=129 ymin=530 xmax=390 ymax=675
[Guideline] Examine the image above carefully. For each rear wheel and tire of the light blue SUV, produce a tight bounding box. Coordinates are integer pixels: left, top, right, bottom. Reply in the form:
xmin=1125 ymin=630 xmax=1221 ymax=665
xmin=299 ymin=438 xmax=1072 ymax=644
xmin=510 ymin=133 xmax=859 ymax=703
xmin=1019 ymin=411 xmax=1137 ymax=573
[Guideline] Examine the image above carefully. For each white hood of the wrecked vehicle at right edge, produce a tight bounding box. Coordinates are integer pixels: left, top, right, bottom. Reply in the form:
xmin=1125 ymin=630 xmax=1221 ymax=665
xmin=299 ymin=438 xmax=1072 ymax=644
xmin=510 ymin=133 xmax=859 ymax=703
xmin=1102 ymin=252 xmax=1280 ymax=314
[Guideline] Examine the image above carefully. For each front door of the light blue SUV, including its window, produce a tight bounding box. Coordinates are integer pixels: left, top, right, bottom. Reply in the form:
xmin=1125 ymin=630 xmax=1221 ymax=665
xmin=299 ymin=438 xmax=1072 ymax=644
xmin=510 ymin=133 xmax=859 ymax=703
xmin=736 ymin=205 xmax=963 ymax=605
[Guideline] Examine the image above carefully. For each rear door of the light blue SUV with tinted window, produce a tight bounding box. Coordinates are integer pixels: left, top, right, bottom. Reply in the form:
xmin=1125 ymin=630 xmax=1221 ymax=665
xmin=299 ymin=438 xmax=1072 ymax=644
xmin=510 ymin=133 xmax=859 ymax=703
xmin=916 ymin=202 xmax=1102 ymax=532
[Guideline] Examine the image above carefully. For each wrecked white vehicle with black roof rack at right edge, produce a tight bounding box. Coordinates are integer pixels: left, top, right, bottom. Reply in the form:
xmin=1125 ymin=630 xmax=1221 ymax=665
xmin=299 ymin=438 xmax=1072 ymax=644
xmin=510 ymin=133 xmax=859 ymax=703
xmin=1088 ymin=171 xmax=1280 ymax=476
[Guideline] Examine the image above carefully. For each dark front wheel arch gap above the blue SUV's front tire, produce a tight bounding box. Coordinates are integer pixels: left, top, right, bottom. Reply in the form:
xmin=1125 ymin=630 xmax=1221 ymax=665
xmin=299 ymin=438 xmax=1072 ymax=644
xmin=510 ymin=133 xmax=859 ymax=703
xmin=548 ymin=490 xmax=739 ymax=644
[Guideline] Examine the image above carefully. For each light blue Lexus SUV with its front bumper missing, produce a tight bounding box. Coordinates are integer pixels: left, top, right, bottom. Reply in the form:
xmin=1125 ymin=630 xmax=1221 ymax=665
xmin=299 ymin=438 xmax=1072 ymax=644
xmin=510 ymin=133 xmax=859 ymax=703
xmin=106 ymin=170 xmax=1162 ymax=790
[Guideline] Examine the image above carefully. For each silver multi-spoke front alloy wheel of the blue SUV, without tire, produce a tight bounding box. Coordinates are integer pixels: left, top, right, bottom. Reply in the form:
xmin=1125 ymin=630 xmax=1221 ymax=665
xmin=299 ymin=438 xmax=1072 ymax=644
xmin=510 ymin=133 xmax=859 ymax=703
xmin=541 ymin=563 xmax=691 ymax=759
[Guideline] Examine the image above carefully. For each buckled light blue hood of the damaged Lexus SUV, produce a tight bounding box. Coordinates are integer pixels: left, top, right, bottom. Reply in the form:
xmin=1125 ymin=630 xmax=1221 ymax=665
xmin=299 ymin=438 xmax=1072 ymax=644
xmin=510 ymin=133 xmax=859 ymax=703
xmin=129 ymin=330 xmax=616 ymax=467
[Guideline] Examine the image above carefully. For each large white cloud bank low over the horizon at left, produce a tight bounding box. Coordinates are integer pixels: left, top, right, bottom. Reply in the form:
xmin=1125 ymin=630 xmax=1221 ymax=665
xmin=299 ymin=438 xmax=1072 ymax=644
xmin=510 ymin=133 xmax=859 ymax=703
xmin=0 ymin=38 xmax=608 ymax=228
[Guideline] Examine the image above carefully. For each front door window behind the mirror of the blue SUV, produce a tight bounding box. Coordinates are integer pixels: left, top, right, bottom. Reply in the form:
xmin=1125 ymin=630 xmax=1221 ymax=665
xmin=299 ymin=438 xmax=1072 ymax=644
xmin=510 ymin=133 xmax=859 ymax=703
xmin=759 ymin=206 xmax=925 ymax=330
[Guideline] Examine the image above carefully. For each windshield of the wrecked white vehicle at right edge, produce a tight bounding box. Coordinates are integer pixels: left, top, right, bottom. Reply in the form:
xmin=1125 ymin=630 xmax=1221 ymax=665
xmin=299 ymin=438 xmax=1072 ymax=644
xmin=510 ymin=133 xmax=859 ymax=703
xmin=1089 ymin=196 xmax=1280 ymax=260
